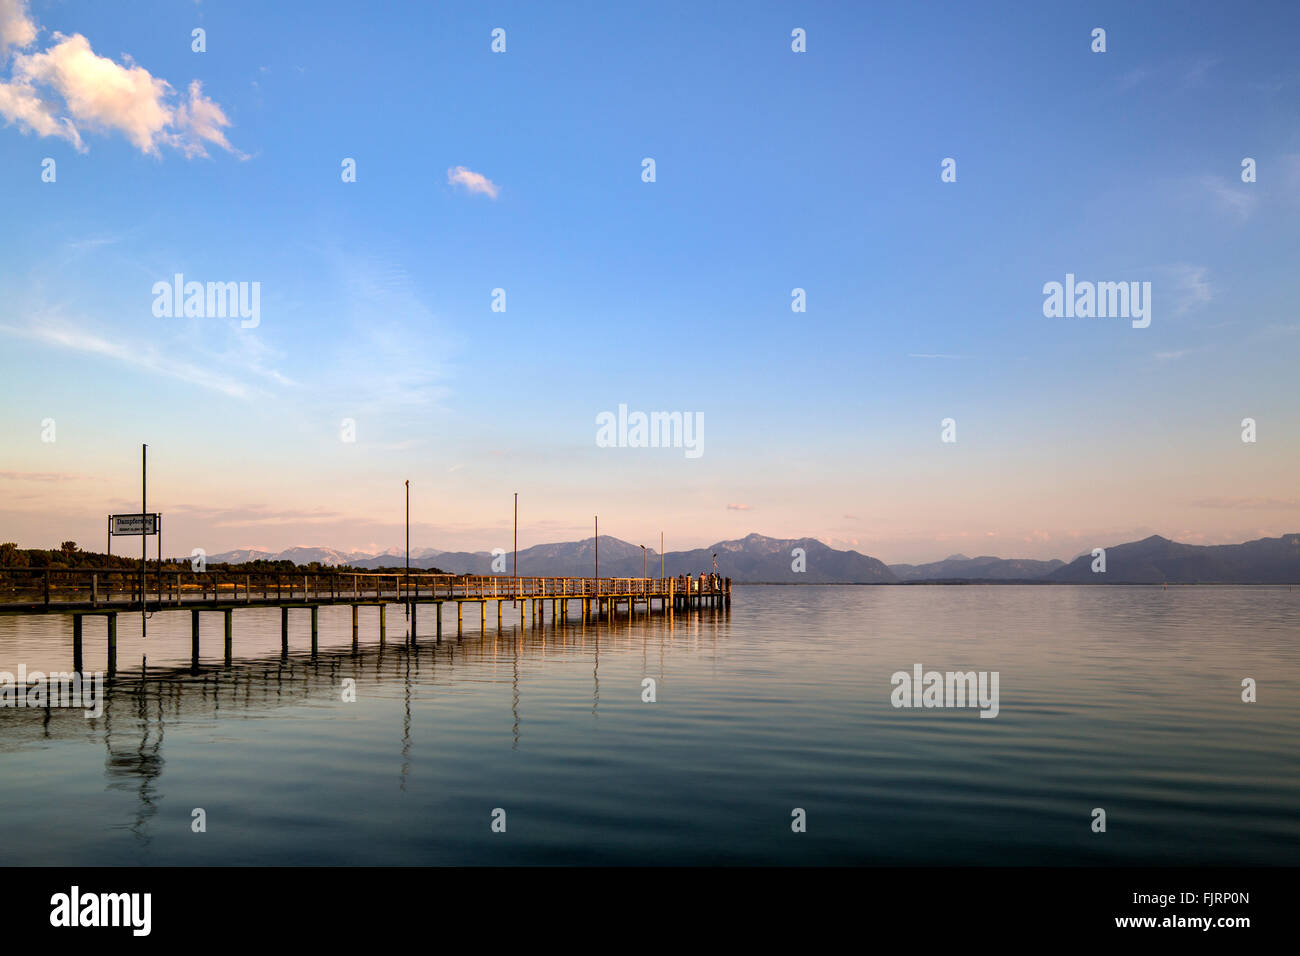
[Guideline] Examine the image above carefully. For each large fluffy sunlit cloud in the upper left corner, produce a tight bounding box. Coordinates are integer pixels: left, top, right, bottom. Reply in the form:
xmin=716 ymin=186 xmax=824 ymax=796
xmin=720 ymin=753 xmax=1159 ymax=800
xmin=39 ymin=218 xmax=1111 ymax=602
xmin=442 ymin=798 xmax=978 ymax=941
xmin=0 ymin=0 xmax=244 ymax=159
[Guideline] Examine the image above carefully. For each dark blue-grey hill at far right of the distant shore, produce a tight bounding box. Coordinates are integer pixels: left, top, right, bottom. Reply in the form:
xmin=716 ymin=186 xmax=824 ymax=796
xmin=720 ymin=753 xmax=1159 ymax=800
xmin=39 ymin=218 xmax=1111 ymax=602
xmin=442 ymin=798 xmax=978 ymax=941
xmin=1045 ymin=535 xmax=1300 ymax=584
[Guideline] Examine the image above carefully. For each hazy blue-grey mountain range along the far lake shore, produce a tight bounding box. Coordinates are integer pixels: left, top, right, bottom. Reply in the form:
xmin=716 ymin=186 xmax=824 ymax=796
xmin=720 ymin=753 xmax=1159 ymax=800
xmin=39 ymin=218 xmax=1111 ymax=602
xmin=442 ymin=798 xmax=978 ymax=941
xmin=208 ymin=533 xmax=1300 ymax=584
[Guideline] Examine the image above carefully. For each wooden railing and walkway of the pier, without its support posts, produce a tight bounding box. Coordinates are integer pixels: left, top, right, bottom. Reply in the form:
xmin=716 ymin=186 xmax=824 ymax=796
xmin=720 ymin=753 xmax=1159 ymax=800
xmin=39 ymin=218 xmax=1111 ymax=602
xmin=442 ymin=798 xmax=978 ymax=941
xmin=0 ymin=566 xmax=731 ymax=610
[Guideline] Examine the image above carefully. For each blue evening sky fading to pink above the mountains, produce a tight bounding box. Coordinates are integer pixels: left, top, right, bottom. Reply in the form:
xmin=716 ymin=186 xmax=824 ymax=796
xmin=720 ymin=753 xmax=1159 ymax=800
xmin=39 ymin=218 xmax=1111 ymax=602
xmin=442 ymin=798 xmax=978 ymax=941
xmin=0 ymin=0 xmax=1300 ymax=561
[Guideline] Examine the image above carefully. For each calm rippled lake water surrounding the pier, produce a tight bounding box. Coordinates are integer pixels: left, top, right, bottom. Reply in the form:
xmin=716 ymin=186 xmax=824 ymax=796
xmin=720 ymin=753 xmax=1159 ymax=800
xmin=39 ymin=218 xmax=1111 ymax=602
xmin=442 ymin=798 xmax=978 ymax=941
xmin=0 ymin=587 xmax=1300 ymax=866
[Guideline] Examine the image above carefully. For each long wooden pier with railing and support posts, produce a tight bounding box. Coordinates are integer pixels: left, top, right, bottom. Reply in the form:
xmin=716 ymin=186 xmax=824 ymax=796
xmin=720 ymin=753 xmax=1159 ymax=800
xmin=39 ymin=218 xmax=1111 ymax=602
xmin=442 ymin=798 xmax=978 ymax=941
xmin=0 ymin=568 xmax=731 ymax=676
